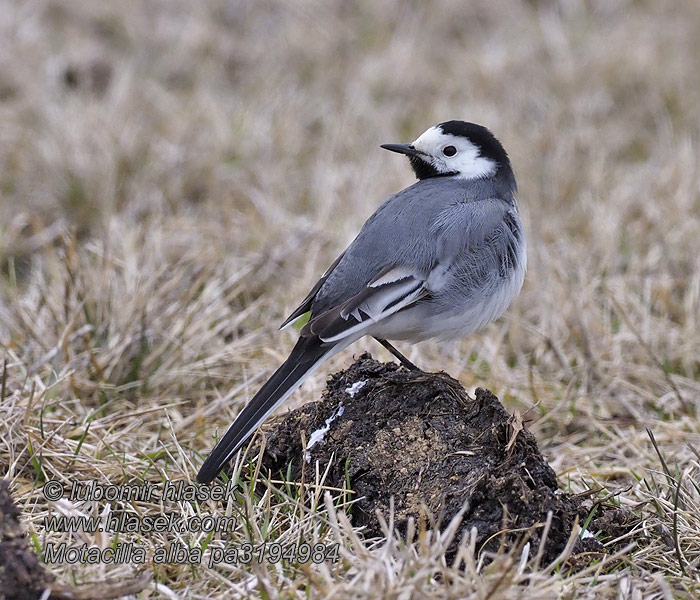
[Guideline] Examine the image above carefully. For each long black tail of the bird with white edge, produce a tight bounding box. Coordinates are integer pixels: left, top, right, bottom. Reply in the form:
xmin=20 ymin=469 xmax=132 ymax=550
xmin=197 ymin=336 xmax=340 ymax=483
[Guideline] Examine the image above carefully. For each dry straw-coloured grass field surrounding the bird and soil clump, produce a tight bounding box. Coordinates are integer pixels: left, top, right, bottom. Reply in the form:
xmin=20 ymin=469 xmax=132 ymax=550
xmin=0 ymin=0 xmax=700 ymax=600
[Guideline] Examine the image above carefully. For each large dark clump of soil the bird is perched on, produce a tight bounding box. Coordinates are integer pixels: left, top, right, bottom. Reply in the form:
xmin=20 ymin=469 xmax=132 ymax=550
xmin=263 ymin=354 xmax=632 ymax=561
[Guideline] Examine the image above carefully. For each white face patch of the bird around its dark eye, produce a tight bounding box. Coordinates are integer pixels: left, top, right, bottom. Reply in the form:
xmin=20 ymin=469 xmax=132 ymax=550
xmin=412 ymin=126 xmax=497 ymax=179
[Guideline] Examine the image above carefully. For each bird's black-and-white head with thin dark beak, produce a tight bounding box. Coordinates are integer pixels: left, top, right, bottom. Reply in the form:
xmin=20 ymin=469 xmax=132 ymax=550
xmin=382 ymin=121 xmax=513 ymax=179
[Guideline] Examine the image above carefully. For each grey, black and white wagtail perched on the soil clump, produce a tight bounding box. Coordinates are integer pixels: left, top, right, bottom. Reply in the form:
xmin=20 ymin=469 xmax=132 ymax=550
xmin=197 ymin=120 xmax=527 ymax=483
